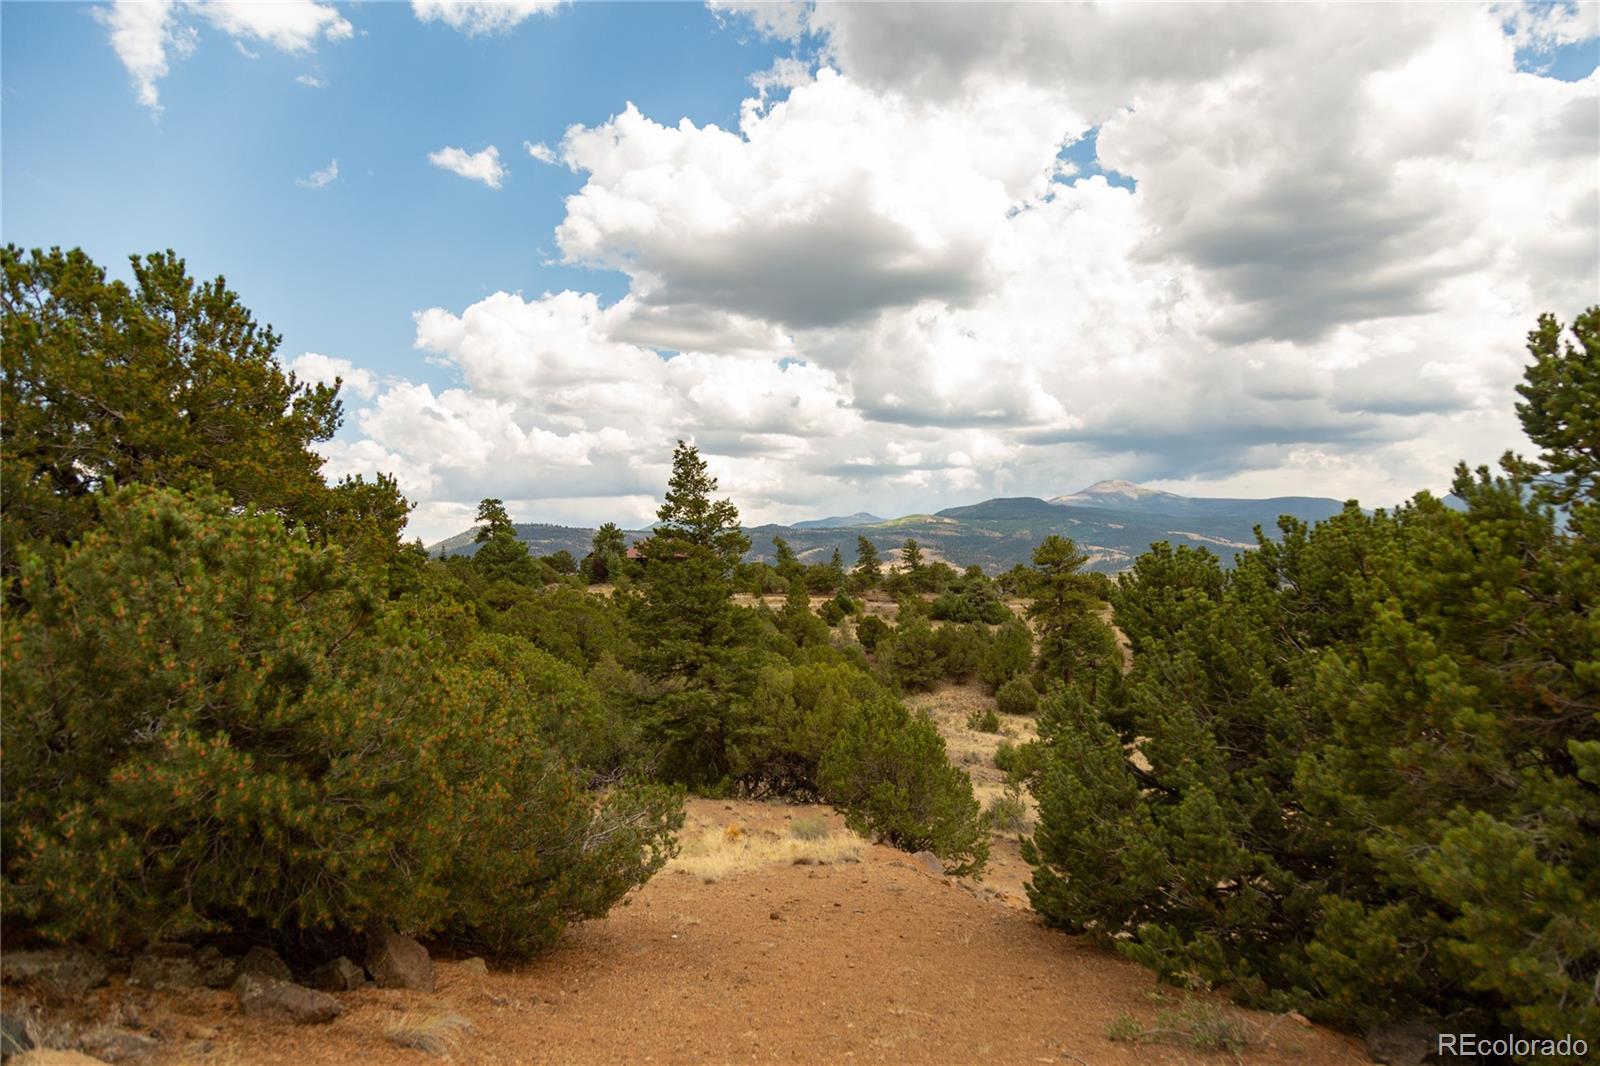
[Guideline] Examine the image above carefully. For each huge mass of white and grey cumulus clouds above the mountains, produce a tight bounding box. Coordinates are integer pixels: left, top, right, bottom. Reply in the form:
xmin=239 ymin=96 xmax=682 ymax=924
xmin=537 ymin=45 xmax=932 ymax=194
xmin=318 ymin=5 xmax=1600 ymax=536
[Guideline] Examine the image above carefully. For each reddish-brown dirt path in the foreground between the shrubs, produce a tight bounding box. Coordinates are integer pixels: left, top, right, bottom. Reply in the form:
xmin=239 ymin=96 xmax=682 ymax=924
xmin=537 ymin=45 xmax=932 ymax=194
xmin=104 ymin=800 xmax=1368 ymax=1066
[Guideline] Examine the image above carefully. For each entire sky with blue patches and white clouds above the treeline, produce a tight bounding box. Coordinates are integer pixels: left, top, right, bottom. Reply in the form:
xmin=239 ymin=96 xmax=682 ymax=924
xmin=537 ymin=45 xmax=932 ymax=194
xmin=0 ymin=0 xmax=1600 ymax=539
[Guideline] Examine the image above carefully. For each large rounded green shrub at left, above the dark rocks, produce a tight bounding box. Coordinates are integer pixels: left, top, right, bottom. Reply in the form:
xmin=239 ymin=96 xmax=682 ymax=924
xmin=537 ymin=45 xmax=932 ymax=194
xmin=3 ymin=488 xmax=680 ymax=952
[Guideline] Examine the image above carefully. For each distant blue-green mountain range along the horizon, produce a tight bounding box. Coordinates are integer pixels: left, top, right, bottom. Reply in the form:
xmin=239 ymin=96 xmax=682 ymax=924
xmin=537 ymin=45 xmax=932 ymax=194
xmin=429 ymin=482 xmax=1344 ymax=573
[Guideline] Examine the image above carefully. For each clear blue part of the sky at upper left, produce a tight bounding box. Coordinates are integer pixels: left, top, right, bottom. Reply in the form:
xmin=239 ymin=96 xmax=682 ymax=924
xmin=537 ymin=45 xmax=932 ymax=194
xmin=0 ymin=2 xmax=787 ymax=386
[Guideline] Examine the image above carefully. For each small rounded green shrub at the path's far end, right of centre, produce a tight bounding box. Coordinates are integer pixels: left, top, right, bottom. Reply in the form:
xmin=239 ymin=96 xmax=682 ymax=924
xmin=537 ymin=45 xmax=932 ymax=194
xmin=821 ymin=699 xmax=989 ymax=874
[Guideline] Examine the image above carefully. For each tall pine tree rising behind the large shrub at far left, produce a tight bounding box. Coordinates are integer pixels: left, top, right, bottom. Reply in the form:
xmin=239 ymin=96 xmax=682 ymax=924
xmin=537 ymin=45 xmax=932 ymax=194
xmin=0 ymin=245 xmax=344 ymax=567
